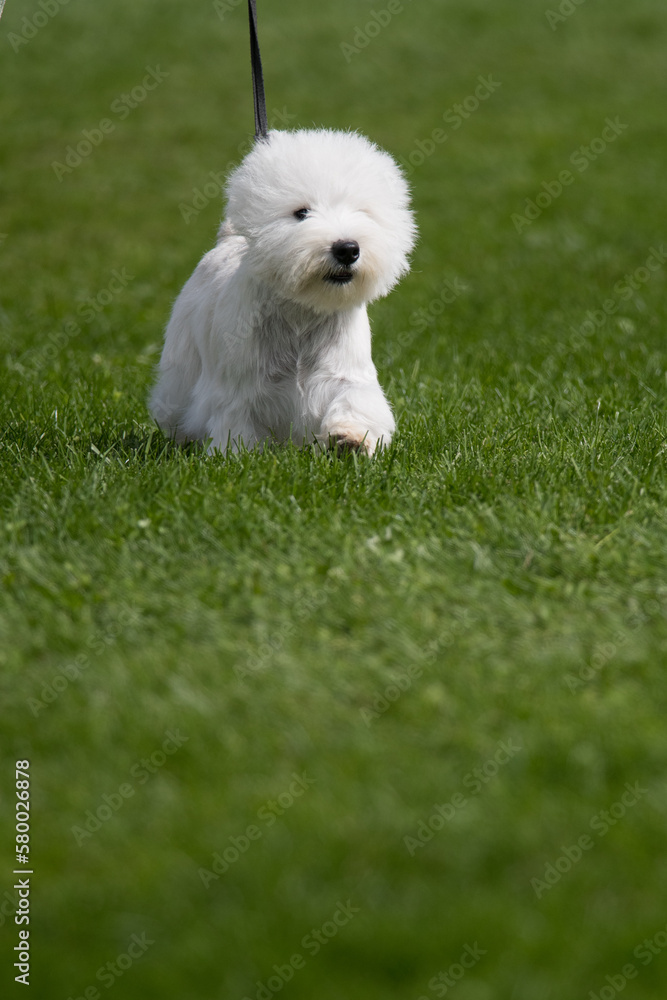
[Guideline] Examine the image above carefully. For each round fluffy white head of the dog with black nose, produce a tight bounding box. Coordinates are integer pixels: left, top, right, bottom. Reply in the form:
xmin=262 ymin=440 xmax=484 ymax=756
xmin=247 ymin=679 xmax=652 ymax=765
xmin=226 ymin=129 xmax=416 ymax=313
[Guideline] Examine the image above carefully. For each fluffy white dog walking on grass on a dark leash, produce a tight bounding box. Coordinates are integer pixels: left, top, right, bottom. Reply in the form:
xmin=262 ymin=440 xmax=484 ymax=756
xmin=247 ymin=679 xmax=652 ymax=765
xmin=150 ymin=130 xmax=416 ymax=454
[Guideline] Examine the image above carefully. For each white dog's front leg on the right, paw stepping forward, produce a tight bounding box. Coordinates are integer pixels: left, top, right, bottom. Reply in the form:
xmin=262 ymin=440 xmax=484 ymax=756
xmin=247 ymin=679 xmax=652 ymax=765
xmin=308 ymin=308 xmax=396 ymax=455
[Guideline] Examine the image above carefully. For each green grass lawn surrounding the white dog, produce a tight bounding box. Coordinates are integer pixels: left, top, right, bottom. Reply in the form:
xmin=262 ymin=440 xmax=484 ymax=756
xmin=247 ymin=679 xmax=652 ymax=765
xmin=0 ymin=0 xmax=667 ymax=1000
